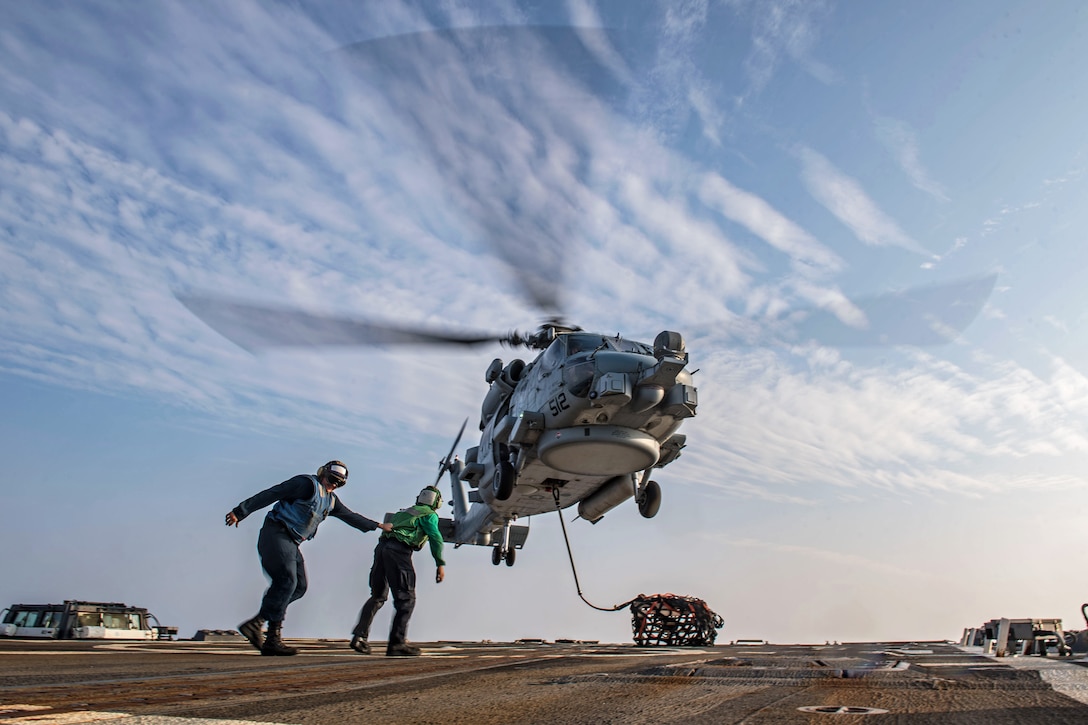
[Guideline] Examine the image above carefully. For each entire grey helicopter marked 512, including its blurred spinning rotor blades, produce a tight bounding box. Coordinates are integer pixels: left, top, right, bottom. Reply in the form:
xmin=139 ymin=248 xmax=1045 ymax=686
xmin=177 ymin=26 xmax=993 ymax=566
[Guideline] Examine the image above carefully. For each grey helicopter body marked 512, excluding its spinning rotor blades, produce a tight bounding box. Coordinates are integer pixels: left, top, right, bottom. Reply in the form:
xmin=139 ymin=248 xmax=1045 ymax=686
xmin=440 ymin=322 xmax=698 ymax=566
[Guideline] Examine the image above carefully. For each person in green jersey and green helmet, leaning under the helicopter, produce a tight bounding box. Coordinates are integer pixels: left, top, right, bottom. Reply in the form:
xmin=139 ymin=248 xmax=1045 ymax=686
xmin=351 ymin=486 xmax=446 ymax=658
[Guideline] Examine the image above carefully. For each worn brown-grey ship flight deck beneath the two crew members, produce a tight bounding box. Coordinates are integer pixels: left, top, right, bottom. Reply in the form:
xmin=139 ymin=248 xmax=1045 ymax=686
xmin=0 ymin=638 xmax=1088 ymax=725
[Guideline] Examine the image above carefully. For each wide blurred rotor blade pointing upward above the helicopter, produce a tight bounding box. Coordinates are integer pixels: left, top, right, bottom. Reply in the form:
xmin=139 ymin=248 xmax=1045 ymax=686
xmin=337 ymin=25 xmax=629 ymax=316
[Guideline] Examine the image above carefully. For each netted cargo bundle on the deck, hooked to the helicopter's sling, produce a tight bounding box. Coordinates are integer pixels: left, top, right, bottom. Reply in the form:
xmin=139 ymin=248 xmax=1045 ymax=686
xmin=631 ymin=594 xmax=725 ymax=647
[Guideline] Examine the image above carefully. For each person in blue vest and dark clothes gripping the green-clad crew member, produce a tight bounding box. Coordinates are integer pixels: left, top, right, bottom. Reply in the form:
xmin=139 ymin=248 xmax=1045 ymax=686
xmin=226 ymin=460 xmax=393 ymax=655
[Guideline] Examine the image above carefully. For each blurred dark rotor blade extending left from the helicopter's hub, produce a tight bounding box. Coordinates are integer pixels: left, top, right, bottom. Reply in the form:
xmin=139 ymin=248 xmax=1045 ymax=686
xmin=175 ymin=294 xmax=521 ymax=352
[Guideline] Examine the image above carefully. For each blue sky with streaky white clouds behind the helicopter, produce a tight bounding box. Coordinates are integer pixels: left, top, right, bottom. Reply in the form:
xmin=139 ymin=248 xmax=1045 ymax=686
xmin=0 ymin=0 xmax=1088 ymax=642
